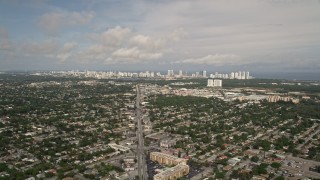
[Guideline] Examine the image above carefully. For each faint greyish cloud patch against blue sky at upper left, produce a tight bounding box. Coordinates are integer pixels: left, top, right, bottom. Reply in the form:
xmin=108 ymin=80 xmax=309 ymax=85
xmin=38 ymin=11 xmax=95 ymax=35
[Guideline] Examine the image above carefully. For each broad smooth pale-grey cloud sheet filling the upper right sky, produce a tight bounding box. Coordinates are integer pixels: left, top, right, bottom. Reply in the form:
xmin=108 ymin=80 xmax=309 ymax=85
xmin=142 ymin=0 xmax=320 ymax=67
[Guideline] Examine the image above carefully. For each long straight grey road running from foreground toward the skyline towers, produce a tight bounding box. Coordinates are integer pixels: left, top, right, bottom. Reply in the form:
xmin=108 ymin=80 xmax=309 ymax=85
xmin=136 ymin=85 xmax=147 ymax=180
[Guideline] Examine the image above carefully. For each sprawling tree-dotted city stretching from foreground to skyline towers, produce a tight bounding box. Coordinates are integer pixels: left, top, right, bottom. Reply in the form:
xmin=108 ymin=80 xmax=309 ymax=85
xmin=0 ymin=70 xmax=320 ymax=180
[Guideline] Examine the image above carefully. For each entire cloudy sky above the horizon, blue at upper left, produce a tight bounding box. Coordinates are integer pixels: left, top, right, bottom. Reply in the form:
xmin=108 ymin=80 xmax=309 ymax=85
xmin=0 ymin=0 xmax=320 ymax=72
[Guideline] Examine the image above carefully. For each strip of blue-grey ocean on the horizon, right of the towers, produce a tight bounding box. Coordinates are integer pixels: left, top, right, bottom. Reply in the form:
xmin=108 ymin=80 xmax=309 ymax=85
xmin=255 ymin=72 xmax=320 ymax=81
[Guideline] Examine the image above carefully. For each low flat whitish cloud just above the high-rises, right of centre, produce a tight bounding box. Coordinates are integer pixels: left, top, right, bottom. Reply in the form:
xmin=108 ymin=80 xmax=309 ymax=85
xmin=174 ymin=54 xmax=243 ymax=66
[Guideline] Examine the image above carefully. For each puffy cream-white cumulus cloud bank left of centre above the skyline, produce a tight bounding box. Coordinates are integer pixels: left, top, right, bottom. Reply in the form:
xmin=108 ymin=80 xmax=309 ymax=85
xmin=73 ymin=26 xmax=181 ymax=64
